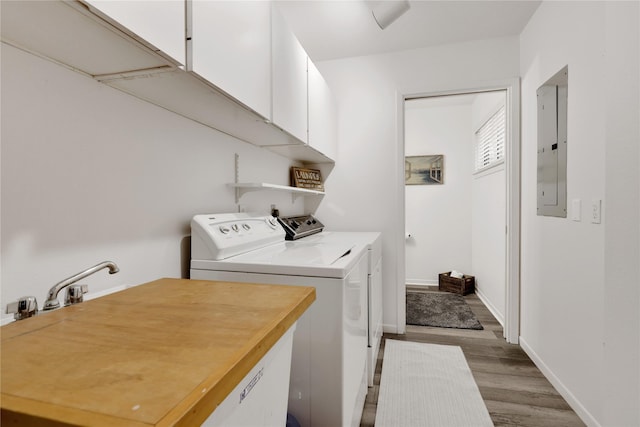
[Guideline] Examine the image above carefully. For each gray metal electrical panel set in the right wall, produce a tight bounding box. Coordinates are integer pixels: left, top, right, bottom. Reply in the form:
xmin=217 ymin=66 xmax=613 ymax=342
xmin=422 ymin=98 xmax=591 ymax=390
xmin=536 ymin=67 xmax=569 ymax=218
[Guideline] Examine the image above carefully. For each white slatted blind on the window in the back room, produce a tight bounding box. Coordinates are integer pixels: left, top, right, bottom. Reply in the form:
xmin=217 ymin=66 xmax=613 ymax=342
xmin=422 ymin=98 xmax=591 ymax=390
xmin=475 ymin=107 xmax=506 ymax=172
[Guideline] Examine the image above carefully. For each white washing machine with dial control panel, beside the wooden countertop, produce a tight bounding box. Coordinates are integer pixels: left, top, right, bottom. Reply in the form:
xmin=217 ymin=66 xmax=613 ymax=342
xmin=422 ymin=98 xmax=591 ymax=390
xmin=191 ymin=214 xmax=368 ymax=427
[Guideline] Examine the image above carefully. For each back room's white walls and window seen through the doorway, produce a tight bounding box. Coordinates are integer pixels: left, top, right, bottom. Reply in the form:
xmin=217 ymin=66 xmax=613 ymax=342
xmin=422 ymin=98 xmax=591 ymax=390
xmin=404 ymin=90 xmax=506 ymax=326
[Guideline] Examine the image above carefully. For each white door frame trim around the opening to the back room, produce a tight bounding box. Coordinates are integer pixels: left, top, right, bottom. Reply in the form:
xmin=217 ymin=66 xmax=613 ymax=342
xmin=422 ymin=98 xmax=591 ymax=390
xmin=396 ymin=78 xmax=521 ymax=344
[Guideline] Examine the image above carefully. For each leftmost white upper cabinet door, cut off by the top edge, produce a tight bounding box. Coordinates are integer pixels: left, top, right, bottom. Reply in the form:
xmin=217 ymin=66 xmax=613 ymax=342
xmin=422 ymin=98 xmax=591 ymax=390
xmin=85 ymin=0 xmax=186 ymax=65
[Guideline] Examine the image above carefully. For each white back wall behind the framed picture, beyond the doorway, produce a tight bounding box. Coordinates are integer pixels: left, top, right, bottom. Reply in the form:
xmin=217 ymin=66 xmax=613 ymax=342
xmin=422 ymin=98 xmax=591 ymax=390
xmin=405 ymin=96 xmax=473 ymax=285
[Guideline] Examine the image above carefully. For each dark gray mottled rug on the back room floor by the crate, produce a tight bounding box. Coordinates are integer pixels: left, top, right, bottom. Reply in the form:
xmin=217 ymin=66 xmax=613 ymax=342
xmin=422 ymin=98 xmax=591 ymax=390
xmin=407 ymin=291 xmax=484 ymax=329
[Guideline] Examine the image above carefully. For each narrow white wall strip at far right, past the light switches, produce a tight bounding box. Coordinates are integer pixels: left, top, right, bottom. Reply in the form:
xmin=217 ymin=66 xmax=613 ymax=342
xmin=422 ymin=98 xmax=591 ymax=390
xmin=603 ymin=2 xmax=640 ymax=425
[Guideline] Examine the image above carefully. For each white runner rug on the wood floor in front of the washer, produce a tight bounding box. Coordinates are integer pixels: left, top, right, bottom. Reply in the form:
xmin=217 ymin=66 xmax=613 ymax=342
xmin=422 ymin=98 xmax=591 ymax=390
xmin=375 ymin=339 xmax=493 ymax=427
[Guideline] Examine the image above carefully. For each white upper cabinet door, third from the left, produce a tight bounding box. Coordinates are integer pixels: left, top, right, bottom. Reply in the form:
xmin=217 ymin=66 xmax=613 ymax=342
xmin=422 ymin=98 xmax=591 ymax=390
xmin=272 ymin=8 xmax=307 ymax=143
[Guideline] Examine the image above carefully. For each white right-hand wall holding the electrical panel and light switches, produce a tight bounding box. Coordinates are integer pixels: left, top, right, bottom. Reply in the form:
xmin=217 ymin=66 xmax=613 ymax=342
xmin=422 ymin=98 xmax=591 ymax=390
xmin=520 ymin=2 xmax=640 ymax=426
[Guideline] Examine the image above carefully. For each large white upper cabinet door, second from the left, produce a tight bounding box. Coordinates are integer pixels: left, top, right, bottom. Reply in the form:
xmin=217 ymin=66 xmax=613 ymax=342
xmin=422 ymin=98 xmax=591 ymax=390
xmin=187 ymin=0 xmax=271 ymax=120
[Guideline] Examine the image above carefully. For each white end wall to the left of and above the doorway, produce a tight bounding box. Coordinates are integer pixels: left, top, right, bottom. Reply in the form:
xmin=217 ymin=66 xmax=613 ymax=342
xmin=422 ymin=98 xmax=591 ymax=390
xmin=317 ymin=38 xmax=519 ymax=331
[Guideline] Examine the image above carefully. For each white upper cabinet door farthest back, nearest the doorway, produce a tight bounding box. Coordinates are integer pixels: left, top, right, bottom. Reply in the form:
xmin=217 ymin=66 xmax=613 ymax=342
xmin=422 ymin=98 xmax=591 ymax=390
xmin=307 ymin=59 xmax=337 ymax=160
